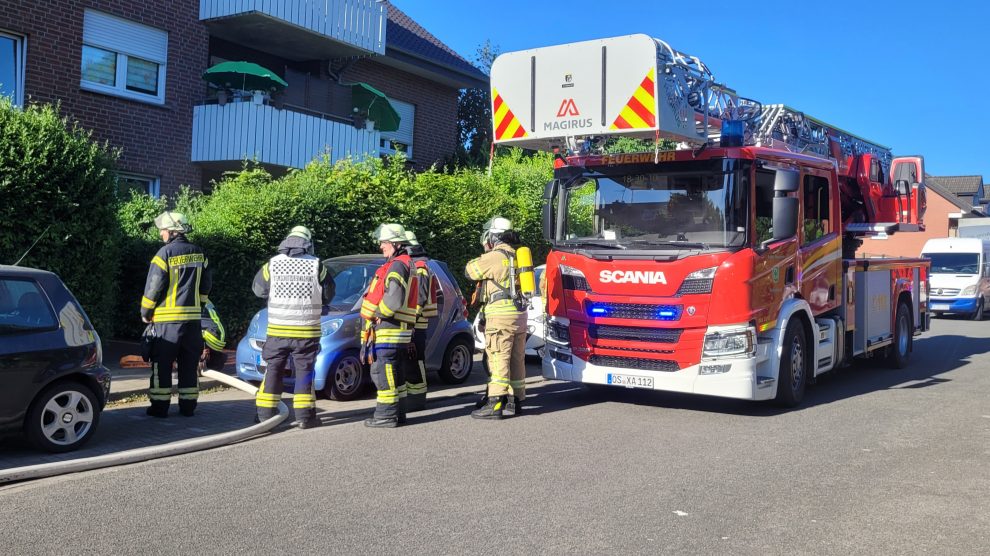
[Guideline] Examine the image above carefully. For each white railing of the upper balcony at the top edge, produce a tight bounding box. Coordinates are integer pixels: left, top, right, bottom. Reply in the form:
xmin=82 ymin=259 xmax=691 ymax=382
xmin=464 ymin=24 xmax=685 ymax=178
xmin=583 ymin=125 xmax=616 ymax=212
xmin=199 ymin=0 xmax=386 ymax=54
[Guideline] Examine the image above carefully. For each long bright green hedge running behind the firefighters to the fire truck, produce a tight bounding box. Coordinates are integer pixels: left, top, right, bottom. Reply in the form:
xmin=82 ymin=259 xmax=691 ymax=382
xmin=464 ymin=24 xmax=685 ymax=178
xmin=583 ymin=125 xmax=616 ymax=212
xmin=118 ymin=151 xmax=552 ymax=336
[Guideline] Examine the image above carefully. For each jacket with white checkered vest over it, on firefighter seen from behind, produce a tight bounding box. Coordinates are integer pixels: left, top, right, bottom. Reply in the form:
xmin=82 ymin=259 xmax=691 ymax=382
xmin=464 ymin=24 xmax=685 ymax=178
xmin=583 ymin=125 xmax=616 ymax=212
xmin=252 ymin=237 xmax=335 ymax=338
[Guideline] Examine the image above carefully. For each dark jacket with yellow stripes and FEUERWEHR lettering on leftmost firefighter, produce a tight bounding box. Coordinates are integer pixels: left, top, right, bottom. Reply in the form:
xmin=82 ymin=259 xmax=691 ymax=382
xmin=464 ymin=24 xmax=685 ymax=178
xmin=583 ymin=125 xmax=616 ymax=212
xmin=141 ymin=234 xmax=212 ymax=322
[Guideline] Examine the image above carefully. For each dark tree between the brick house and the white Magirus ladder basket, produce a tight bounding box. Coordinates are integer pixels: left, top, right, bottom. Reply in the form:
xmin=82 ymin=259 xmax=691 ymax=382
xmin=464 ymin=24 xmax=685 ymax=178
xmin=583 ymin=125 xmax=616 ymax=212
xmin=453 ymin=40 xmax=501 ymax=167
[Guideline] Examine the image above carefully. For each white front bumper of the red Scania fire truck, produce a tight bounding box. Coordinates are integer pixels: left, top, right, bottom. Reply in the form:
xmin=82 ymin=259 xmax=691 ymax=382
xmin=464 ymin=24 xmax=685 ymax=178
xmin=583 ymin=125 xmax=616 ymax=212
xmin=543 ymin=344 xmax=776 ymax=400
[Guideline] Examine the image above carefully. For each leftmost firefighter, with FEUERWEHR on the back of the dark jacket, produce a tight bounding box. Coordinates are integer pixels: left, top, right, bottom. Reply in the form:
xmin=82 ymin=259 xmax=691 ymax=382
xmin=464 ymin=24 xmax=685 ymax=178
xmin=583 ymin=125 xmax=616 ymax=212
xmin=141 ymin=212 xmax=212 ymax=417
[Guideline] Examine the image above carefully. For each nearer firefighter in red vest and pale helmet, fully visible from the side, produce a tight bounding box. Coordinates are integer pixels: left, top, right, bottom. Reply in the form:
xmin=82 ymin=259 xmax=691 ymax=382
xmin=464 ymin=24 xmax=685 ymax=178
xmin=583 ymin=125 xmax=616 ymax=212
xmin=361 ymin=224 xmax=419 ymax=428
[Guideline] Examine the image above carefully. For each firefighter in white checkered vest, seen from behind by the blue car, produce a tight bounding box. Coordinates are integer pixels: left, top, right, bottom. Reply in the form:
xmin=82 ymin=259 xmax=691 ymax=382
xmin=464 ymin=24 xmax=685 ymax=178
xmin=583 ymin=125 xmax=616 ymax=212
xmin=252 ymin=226 xmax=334 ymax=429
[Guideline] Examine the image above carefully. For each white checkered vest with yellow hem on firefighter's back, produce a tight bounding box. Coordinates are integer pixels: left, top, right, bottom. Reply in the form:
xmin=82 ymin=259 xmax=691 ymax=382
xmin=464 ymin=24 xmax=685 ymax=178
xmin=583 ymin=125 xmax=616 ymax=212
xmin=266 ymin=255 xmax=323 ymax=338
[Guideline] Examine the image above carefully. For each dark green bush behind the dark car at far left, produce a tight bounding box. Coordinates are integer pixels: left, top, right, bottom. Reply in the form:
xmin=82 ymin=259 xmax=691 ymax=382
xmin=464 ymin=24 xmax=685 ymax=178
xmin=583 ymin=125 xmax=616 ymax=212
xmin=0 ymin=96 xmax=120 ymax=338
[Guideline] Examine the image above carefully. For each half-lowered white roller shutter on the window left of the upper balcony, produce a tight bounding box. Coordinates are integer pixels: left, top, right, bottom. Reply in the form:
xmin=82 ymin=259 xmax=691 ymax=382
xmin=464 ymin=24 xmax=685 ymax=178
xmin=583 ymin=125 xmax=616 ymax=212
xmin=83 ymin=10 xmax=168 ymax=65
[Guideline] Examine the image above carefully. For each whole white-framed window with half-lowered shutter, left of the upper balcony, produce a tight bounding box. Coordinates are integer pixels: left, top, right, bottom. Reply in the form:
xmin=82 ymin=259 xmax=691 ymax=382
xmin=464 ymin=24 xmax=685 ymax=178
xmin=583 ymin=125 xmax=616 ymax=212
xmin=81 ymin=10 xmax=168 ymax=104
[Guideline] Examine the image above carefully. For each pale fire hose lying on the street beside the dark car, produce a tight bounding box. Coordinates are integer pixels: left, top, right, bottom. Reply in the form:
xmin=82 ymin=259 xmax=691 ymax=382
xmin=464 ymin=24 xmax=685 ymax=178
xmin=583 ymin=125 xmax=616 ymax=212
xmin=0 ymin=370 xmax=289 ymax=484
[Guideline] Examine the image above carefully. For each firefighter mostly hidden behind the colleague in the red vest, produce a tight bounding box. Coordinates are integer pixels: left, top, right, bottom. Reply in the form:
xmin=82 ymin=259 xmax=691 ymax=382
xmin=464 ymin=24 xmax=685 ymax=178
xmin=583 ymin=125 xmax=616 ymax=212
xmin=406 ymin=230 xmax=440 ymax=412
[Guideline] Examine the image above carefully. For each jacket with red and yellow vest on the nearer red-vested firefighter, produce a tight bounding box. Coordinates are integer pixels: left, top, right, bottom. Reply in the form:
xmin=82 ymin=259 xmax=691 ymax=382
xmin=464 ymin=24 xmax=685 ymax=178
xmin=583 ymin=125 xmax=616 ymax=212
xmin=361 ymin=252 xmax=419 ymax=345
